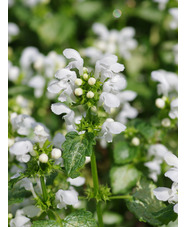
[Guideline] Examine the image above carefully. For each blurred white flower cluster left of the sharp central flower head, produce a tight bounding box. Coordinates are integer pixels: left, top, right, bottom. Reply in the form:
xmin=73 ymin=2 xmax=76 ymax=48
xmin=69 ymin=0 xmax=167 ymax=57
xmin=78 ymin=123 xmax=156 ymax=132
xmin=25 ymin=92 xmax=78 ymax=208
xmin=8 ymin=47 xmax=66 ymax=98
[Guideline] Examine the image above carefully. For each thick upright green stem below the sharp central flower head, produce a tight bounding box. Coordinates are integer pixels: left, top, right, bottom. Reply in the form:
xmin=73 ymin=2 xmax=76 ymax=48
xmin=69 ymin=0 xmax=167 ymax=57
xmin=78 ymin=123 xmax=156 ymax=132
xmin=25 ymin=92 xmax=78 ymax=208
xmin=91 ymin=151 xmax=103 ymax=227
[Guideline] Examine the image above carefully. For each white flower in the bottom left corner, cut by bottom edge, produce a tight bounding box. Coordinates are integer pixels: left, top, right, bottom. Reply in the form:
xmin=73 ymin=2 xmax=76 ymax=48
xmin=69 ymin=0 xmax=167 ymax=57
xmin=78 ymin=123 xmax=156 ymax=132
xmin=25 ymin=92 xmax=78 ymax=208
xmin=10 ymin=210 xmax=32 ymax=227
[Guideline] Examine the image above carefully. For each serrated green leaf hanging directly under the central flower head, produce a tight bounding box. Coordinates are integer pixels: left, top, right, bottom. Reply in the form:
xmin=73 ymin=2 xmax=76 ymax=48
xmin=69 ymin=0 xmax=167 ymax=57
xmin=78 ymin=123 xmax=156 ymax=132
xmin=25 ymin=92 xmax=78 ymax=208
xmin=62 ymin=132 xmax=88 ymax=178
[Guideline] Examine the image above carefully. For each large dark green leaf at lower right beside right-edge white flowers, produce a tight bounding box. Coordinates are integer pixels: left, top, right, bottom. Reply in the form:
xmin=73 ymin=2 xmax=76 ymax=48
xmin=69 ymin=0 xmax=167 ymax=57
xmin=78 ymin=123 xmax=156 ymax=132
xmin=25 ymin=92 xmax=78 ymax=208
xmin=127 ymin=179 xmax=177 ymax=226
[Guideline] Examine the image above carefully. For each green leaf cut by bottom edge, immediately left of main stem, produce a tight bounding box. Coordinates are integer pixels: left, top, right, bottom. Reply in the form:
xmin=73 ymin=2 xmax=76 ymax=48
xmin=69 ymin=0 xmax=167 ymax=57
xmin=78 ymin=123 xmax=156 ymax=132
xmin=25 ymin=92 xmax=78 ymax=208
xmin=63 ymin=210 xmax=97 ymax=227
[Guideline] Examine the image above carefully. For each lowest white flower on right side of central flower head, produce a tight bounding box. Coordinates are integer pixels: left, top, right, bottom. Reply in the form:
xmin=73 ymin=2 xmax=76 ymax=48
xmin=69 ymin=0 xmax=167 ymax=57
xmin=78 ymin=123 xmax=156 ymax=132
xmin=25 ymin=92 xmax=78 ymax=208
xmin=101 ymin=118 xmax=126 ymax=143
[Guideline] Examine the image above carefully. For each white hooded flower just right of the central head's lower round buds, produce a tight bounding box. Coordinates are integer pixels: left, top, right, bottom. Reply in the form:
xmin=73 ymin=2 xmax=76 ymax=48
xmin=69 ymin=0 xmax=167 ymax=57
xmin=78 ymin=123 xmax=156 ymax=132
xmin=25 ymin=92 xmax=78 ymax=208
xmin=99 ymin=92 xmax=120 ymax=113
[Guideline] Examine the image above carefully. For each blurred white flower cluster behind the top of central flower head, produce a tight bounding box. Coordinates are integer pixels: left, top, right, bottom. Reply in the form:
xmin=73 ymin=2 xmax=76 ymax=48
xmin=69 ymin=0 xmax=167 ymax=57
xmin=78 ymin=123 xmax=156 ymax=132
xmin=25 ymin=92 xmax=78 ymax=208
xmin=82 ymin=23 xmax=137 ymax=63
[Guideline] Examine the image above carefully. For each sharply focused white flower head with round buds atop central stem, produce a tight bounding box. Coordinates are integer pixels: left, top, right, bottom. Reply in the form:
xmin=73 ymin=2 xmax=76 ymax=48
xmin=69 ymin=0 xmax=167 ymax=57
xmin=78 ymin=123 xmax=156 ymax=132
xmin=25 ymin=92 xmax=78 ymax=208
xmin=48 ymin=49 xmax=126 ymax=142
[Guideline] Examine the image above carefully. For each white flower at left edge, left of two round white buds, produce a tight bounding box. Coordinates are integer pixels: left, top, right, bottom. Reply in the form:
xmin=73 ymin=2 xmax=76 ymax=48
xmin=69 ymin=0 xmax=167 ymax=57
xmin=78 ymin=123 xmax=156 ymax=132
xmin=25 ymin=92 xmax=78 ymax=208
xmin=9 ymin=140 xmax=33 ymax=162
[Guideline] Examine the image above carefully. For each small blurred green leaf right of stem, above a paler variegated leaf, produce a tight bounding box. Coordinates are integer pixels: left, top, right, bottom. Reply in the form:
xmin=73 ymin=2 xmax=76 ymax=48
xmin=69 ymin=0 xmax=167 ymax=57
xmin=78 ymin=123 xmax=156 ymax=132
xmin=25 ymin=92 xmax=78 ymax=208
xmin=113 ymin=142 xmax=138 ymax=164
